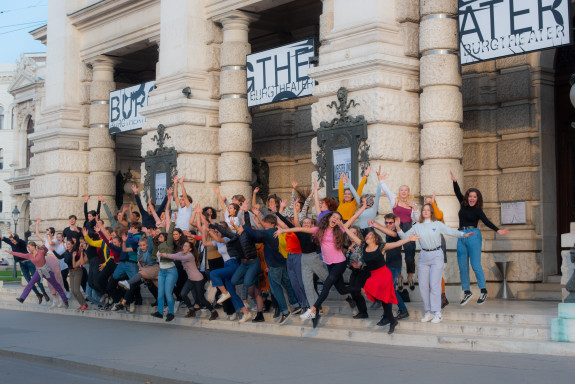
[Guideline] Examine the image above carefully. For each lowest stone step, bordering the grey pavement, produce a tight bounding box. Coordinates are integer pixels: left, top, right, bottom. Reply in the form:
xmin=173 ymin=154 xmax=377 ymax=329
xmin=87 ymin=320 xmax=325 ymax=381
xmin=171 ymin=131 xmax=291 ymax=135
xmin=0 ymin=301 xmax=575 ymax=357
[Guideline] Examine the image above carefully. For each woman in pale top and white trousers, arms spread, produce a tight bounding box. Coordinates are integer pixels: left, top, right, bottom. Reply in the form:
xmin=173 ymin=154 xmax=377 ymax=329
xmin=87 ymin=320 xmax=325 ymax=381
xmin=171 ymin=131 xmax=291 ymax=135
xmin=395 ymin=204 xmax=473 ymax=323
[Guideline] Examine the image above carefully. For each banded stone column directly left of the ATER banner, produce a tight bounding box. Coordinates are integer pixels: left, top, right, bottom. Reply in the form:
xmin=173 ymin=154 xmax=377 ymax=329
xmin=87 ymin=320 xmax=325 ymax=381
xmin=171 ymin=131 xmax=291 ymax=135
xmin=419 ymin=0 xmax=463 ymax=225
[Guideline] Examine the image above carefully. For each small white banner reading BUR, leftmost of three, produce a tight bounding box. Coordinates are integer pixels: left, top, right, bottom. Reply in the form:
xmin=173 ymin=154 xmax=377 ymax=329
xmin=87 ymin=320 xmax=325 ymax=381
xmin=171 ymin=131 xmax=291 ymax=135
xmin=109 ymin=81 xmax=154 ymax=135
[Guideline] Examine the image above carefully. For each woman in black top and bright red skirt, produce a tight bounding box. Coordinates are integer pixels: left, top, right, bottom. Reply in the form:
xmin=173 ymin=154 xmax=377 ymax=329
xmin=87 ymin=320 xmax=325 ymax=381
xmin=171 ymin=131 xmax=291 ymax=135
xmin=348 ymin=231 xmax=419 ymax=335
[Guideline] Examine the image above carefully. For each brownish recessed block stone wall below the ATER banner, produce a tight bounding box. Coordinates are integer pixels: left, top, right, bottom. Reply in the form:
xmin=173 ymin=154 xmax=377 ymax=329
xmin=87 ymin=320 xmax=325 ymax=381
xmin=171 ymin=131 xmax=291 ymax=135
xmin=462 ymin=55 xmax=553 ymax=282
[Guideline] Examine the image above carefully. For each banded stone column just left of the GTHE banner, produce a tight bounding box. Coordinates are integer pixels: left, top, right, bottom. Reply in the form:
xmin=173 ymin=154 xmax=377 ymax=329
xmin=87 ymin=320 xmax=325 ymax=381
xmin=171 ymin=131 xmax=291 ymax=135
xmin=214 ymin=11 xmax=256 ymax=198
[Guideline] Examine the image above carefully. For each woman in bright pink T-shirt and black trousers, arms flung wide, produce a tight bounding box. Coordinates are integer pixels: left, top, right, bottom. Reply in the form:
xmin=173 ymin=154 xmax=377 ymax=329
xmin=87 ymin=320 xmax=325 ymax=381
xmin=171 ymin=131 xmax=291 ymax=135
xmin=274 ymin=202 xmax=367 ymax=328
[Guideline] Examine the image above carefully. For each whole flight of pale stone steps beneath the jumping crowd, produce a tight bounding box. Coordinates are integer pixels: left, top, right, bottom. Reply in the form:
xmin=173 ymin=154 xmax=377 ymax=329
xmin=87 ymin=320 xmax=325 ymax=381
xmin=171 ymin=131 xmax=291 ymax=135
xmin=0 ymin=284 xmax=575 ymax=357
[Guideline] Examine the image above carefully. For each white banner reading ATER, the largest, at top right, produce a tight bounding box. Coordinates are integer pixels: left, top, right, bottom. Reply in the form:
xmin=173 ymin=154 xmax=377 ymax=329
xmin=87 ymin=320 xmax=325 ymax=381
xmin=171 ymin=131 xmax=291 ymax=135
xmin=459 ymin=0 xmax=572 ymax=65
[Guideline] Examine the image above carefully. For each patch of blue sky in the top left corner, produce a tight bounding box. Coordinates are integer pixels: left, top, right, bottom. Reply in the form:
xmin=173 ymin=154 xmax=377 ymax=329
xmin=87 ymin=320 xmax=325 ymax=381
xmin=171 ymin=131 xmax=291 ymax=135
xmin=0 ymin=0 xmax=48 ymax=64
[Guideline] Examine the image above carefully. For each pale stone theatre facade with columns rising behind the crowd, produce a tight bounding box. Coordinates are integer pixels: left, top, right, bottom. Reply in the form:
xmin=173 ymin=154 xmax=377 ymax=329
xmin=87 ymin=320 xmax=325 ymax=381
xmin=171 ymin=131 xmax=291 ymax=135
xmin=12 ymin=0 xmax=574 ymax=291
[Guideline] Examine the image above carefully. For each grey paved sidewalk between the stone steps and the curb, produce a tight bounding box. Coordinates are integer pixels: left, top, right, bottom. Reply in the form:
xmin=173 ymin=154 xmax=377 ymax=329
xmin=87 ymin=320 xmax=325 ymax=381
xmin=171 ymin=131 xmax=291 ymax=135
xmin=0 ymin=310 xmax=575 ymax=384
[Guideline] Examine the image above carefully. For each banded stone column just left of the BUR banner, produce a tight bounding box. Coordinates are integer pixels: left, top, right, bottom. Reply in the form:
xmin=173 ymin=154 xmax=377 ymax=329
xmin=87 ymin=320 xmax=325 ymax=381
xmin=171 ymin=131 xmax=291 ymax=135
xmin=88 ymin=56 xmax=116 ymax=204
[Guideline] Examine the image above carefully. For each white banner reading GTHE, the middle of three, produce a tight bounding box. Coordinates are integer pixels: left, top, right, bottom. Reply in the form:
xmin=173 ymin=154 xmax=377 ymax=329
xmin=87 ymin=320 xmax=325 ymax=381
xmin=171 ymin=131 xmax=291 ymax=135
xmin=246 ymin=39 xmax=315 ymax=107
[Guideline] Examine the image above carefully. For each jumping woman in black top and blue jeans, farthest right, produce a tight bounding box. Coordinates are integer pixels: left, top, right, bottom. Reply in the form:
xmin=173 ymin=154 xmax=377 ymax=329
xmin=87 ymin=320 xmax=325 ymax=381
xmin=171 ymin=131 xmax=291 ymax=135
xmin=449 ymin=171 xmax=509 ymax=305
